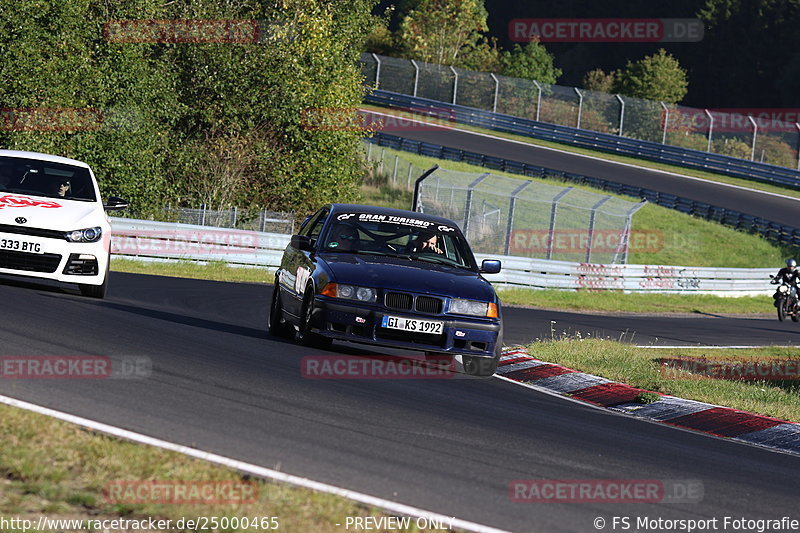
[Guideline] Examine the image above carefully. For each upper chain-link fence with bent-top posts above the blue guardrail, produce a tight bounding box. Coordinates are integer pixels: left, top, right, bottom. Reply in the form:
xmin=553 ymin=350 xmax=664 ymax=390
xmin=361 ymin=54 xmax=800 ymax=169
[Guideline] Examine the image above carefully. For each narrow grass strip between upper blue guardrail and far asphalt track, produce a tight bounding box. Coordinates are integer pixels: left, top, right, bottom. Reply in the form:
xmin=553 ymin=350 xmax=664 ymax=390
xmin=360 ymin=105 xmax=800 ymax=202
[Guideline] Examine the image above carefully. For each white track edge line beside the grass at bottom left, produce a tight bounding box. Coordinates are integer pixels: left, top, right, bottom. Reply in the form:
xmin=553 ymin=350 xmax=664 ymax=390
xmin=0 ymin=395 xmax=510 ymax=533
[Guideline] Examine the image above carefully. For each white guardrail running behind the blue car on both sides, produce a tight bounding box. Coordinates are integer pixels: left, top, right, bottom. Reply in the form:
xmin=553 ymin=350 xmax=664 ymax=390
xmin=111 ymin=218 xmax=776 ymax=296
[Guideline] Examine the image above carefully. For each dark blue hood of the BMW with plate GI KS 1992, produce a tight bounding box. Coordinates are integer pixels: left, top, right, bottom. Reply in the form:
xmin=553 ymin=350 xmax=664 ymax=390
xmin=320 ymin=253 xmax=495 ymax=302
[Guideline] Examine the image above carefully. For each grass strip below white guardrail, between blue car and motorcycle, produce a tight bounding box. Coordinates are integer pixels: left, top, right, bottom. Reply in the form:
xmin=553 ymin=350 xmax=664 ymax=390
xmin=497 ymin=289 xmax=775 ymax=315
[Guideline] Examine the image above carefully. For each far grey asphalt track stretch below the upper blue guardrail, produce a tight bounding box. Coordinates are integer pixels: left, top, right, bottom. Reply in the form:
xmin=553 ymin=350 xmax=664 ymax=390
xmin=362 ymin=109 xmax=800 ymax=226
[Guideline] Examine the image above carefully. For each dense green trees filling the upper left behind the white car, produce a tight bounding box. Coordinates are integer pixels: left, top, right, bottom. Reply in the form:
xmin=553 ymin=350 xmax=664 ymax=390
xmin=0 ymin=0 xmax=375 ymax=211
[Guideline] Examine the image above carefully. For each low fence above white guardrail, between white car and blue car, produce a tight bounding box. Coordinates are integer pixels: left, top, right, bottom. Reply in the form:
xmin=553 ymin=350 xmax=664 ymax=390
xmin=114 ymin=206 xmax=295 ymax=234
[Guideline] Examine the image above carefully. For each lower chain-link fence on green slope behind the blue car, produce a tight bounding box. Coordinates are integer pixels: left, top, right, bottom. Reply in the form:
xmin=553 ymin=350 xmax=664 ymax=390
xmin=416 ymin=169 xmax=644 ymax=264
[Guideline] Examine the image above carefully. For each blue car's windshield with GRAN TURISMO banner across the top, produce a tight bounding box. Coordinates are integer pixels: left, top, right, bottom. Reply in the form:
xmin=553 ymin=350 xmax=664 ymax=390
xmin=322 ymin=213 xmax=476 ymax=270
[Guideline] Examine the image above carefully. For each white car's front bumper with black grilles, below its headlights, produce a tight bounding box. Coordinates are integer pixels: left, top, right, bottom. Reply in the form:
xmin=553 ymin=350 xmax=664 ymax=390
xmin=0 ymin=232 xmax=109 ymax=285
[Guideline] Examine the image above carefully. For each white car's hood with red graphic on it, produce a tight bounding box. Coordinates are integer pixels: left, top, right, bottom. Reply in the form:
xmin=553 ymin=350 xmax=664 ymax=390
xmin=0 ymin=192 xmax=107 ymax=231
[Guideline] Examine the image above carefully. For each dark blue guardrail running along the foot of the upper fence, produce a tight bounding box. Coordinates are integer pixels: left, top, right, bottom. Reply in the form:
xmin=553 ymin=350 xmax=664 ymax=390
xmin=364 ymin=90 xmax=800 ymax=189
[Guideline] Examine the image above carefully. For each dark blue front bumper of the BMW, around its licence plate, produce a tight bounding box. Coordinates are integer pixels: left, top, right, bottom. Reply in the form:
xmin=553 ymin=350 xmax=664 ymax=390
xmin=312 ymin=296 xmax=502 ymax=358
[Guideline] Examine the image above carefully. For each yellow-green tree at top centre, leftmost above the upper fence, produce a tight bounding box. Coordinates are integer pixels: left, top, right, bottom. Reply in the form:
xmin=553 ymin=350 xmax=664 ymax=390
xmin=398 ymin=0 xmax=489 ymax=66
